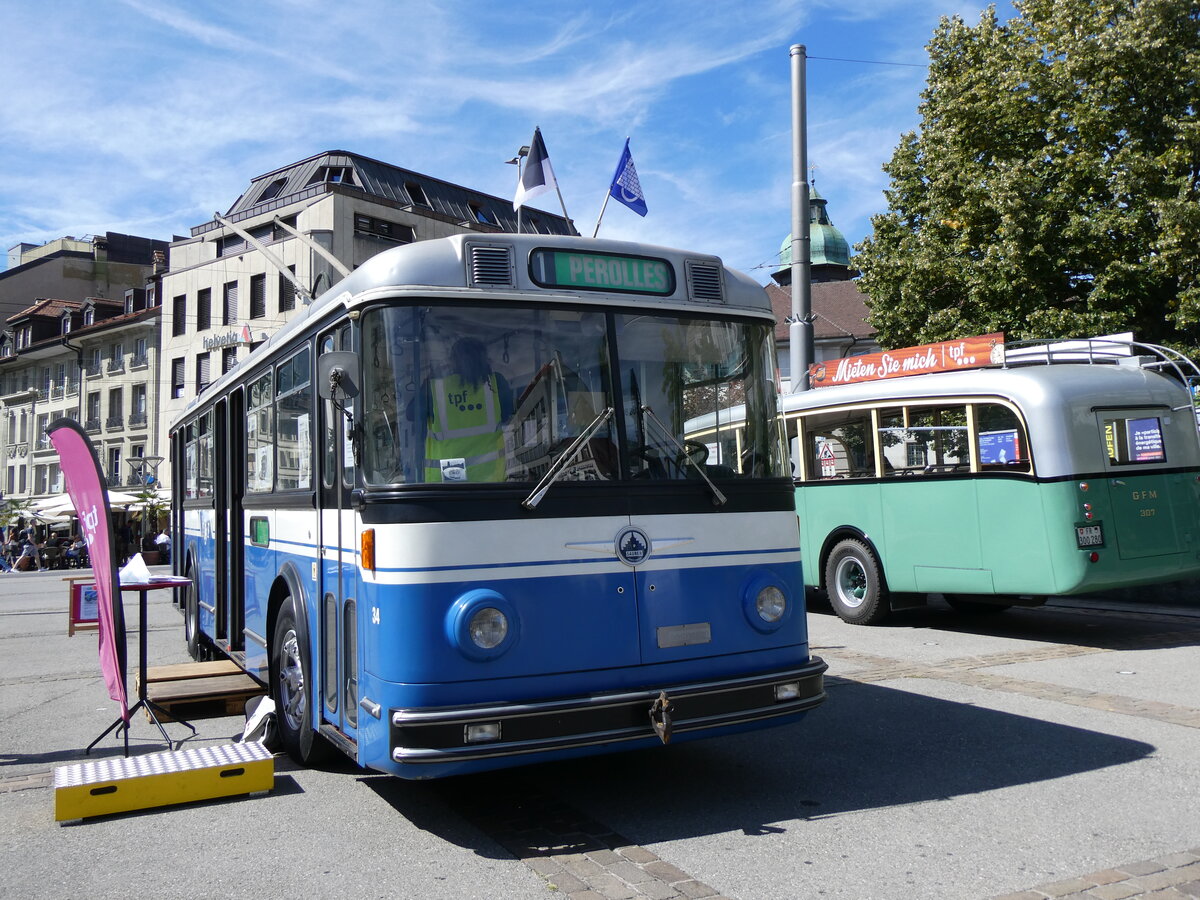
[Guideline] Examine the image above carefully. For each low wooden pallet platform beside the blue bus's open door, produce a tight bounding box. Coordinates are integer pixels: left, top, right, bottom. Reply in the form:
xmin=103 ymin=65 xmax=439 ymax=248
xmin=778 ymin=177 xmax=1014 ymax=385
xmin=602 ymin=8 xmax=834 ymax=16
xmin=137 ymin=660 xmax=266 ymax=721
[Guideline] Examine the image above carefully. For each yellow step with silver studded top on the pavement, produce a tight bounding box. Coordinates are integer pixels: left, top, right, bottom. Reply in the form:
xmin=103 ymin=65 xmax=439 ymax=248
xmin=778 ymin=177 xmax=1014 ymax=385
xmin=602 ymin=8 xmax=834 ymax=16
xmin=54 ymin=742 xmax=275 ymax=822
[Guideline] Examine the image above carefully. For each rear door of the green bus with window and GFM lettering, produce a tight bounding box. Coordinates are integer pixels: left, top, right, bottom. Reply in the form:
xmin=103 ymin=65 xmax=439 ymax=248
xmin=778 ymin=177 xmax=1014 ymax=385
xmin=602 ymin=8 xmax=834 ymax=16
xmin=1099 ymin=407 xmax=1190 ymax=559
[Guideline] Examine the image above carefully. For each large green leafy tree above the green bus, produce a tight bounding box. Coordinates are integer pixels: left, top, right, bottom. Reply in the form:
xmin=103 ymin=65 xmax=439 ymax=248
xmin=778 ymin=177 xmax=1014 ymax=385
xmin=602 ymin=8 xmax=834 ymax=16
xmin=854 ymin=0 xmax=1200 ymax=348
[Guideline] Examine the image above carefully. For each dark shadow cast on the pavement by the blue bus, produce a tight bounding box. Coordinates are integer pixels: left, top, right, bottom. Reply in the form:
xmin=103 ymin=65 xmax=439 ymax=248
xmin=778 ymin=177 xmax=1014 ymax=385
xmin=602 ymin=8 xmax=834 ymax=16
xmin=372 ymin=684 xmax=1154 ymax=856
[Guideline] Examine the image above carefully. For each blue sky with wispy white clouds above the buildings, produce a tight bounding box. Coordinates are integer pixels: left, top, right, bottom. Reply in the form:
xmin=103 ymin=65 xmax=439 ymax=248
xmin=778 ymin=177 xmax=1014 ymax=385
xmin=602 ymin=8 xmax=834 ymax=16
xmin=0 ymin=0 xmax=984 ymax=282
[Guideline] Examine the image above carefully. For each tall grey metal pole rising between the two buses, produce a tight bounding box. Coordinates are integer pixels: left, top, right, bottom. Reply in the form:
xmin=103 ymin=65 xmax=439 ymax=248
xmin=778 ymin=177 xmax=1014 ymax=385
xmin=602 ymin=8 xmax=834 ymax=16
xmin=787 ymin=43 xmax=815 ymax=394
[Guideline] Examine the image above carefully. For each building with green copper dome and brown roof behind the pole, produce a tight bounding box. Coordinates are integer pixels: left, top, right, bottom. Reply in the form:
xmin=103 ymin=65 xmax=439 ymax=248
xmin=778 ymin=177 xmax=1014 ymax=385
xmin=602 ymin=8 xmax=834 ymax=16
xmin=767 ymin=187 xmax=881 ymax=392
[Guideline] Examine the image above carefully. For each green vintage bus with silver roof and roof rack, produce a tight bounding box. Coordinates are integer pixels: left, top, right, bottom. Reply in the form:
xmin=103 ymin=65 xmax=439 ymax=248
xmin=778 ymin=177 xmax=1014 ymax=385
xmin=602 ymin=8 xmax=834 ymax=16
xmin=689 ymin=338 xmax=1200 ymax=624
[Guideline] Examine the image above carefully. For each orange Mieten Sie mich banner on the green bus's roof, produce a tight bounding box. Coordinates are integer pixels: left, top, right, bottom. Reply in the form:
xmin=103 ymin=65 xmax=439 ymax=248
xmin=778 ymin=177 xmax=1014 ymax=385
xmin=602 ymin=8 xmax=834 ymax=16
xmin=809 ymin=331 xmax=1004 ymax=388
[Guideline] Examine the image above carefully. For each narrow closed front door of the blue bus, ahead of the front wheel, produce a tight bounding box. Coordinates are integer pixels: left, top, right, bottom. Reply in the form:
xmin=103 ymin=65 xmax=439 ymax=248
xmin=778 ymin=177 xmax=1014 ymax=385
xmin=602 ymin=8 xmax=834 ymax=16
xmin=310 ymin=325 xmax=359 ymax=740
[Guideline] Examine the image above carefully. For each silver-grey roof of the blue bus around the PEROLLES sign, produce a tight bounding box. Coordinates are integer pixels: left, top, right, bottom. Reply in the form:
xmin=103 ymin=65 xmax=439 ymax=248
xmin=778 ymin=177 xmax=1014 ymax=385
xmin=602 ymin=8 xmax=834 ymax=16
xmin=170 ymin=233 xmax=774 ymax=431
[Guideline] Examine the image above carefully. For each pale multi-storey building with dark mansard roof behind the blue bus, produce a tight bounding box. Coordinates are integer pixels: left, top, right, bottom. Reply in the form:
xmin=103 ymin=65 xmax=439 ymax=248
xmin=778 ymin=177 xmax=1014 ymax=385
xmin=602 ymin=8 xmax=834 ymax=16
xmin=161 ymin=150 xmax=578 ymax=475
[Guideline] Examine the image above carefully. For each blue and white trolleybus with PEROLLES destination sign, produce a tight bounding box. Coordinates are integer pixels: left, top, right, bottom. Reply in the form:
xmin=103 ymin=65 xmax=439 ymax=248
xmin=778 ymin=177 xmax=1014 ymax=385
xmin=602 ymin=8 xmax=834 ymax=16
xmin=172 ymin=234 xmax=826 ymax=778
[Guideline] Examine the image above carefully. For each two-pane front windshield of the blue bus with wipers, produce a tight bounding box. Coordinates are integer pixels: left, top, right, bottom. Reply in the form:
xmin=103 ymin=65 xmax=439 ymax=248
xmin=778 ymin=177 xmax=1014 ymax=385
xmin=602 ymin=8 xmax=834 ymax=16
xmin=361 ymin=305 xmax=782 ymax=485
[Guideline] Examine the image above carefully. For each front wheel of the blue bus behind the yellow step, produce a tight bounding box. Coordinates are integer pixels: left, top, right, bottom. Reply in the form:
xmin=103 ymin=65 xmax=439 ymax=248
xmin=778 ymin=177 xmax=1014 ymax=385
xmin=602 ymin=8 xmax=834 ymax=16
xmin=271 ymin=596 xmax=330 ymax=766
